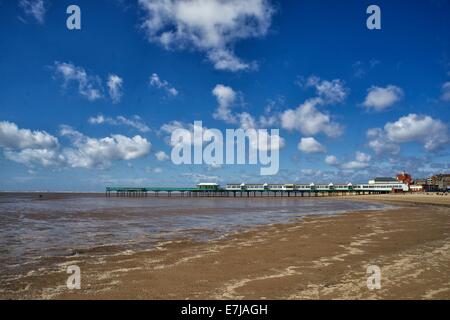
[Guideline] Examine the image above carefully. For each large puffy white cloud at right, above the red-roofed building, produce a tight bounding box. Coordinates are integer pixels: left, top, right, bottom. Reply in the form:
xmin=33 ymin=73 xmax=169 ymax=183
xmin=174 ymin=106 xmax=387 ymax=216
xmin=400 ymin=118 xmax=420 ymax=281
xmin=367 ymin=113 xmax=449 ymax=154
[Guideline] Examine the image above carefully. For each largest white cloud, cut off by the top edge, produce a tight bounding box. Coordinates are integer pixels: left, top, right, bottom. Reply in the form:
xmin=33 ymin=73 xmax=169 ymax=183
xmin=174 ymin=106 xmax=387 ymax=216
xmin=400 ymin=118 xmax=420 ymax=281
xmin=139 ymin=0 xmax=274 ymax=71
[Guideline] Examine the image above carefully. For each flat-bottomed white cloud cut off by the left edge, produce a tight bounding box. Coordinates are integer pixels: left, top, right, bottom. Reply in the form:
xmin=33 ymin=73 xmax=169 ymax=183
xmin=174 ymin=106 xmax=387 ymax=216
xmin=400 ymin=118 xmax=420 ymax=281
xmin=0 ymin=121 xmax=58 ymax=149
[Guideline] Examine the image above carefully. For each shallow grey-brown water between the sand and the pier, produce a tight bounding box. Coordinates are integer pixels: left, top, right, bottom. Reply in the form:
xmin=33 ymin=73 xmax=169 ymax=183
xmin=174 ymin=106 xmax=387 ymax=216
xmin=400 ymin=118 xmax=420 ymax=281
xmin=0 ymin=194 xmax=386 ymax=272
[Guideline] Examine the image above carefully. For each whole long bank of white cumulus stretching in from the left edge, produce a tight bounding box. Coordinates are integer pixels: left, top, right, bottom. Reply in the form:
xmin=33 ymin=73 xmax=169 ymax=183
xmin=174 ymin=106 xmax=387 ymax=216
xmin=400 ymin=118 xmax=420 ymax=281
xmin=0 ymin=121 xmax=151 ymax=168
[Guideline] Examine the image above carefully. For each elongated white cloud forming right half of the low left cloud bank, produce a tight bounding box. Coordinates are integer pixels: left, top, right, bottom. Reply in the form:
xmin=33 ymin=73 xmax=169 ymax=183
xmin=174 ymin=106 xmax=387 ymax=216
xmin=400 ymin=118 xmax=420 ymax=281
xmin=61 ymin=126 xmax=151 ymax=168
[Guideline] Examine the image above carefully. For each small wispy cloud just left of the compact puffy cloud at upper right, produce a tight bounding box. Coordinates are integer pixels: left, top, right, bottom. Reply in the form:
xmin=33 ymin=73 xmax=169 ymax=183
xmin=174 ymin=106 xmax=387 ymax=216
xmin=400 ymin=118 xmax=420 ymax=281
xmin=305 ymin=76 xmax=348 ymax=104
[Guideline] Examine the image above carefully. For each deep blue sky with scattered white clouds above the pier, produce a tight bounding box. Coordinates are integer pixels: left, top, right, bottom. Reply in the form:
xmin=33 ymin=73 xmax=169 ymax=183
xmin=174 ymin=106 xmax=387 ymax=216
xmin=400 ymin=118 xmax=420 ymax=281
xmin=0 ymin=0 xmax=450 ymax=191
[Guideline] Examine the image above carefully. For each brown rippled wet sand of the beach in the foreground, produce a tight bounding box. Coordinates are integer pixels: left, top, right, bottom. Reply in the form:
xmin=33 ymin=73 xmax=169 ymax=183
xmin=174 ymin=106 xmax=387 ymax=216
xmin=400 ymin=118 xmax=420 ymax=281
xmin=0 ymin=195 xmax=450 ymax=299
